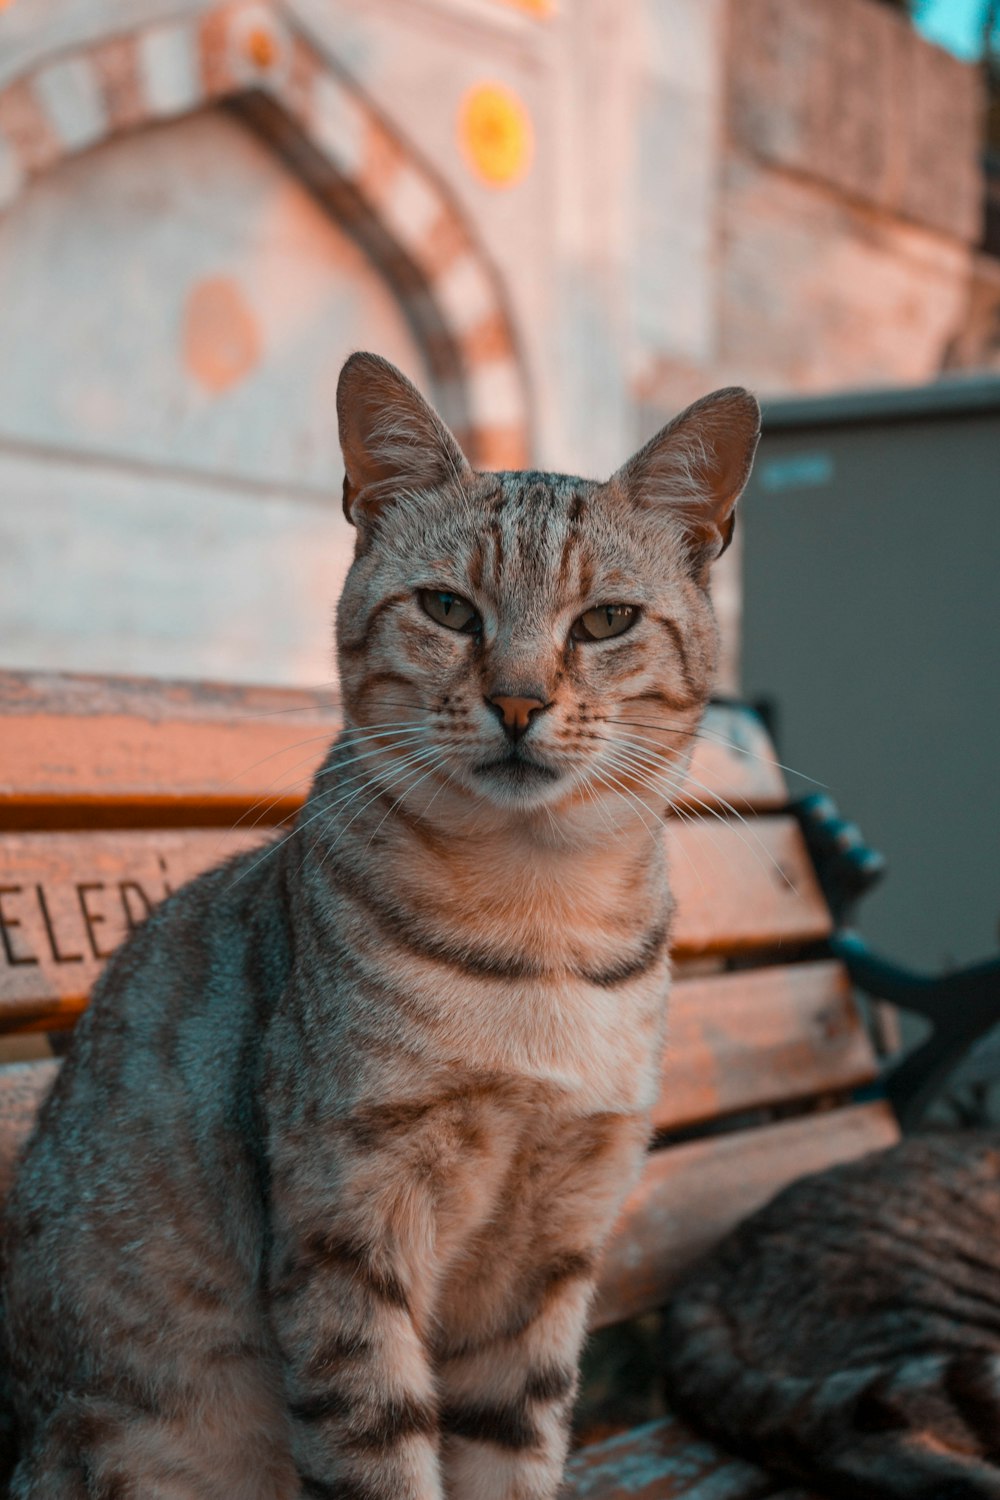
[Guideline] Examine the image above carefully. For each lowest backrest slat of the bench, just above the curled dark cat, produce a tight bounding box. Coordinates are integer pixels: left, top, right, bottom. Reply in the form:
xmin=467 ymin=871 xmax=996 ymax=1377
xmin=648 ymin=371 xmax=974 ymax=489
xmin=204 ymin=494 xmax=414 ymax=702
xmin=591 ymin=1104 xmax=900 ymax=1328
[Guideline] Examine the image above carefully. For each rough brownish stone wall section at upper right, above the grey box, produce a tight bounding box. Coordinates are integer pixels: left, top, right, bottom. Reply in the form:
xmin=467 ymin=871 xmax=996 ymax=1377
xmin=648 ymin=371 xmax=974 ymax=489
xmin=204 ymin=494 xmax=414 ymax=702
xmin=642 ymin=0 xmax=984 ymax=410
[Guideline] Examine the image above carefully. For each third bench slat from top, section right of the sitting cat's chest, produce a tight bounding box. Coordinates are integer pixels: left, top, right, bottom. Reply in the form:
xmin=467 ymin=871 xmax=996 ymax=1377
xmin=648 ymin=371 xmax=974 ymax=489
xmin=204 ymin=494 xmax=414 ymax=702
xmin=654 ymin=962 xmax=879 ymax=1130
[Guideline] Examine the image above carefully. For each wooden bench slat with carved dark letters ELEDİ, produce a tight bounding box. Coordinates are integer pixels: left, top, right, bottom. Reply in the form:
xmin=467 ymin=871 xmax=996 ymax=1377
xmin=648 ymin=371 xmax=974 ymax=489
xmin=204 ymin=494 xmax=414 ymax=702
xmin=0 ymin=818 xmax=829 ymax=1031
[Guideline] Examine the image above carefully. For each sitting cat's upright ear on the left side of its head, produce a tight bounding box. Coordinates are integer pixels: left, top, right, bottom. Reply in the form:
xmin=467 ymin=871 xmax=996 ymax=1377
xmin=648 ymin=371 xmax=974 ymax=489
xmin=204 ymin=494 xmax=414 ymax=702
xmin=337 ymin=354 xmax=472 ymax=525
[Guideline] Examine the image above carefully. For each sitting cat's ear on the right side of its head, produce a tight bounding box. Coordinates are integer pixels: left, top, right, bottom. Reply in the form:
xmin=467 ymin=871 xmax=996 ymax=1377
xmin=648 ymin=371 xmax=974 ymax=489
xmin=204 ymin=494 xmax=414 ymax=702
xmin=612 ymin=386 xmax=760 ymax=573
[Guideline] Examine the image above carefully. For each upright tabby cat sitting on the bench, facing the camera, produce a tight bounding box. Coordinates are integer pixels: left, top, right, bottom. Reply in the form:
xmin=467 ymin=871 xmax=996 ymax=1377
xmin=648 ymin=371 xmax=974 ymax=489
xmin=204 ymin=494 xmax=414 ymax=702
xmin=3 ymin=354 xmax=759 ymax=1500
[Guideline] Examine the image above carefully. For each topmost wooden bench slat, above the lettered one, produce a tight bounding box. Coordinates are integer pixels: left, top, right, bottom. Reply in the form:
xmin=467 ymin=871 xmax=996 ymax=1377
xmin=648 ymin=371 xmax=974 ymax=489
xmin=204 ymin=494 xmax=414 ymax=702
xmin=0 ymin=672 xmax=787 ymax=828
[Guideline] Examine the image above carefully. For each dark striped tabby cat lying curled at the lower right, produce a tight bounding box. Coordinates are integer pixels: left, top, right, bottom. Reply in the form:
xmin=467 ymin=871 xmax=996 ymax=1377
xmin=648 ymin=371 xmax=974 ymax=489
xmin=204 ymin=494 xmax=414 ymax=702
xmin=663 ymin=1131 xmax=1000 ymax=1500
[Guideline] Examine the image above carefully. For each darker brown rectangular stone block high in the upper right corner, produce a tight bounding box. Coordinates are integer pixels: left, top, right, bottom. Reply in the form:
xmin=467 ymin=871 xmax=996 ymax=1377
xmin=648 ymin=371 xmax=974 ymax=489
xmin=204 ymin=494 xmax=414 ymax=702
xmin=729 ymin=0 xmax=982 ymax=243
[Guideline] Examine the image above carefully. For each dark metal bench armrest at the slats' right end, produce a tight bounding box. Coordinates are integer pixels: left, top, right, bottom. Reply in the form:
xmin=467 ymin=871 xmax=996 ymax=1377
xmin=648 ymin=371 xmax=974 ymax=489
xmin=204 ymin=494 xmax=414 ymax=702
xmin=793 ymin=795 xmax=1000 ymax=1130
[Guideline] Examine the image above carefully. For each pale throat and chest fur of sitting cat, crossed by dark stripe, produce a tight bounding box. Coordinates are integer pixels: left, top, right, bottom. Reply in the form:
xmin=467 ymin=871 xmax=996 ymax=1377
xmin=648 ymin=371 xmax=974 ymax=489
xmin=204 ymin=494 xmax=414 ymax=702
xmin=371 ymin=831 xmax=670 ymax=1115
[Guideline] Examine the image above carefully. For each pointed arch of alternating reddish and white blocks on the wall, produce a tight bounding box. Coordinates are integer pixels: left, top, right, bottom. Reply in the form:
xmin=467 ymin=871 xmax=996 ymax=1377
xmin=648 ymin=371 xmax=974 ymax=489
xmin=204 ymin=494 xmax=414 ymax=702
xmin=0 ymin=0 xmax=531 ymax=468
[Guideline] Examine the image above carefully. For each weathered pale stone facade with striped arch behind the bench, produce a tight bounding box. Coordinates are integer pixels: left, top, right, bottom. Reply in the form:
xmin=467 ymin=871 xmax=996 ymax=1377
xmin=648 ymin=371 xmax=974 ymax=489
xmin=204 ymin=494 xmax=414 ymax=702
xmin=0 ymin=0 xmax=996 ymax=681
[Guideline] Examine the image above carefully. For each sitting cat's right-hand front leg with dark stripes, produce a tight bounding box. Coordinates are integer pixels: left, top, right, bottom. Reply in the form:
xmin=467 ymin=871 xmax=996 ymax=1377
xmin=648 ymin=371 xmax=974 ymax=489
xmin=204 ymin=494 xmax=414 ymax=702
xmin=438 ymin=1113 xmax=649 ymax=1500
